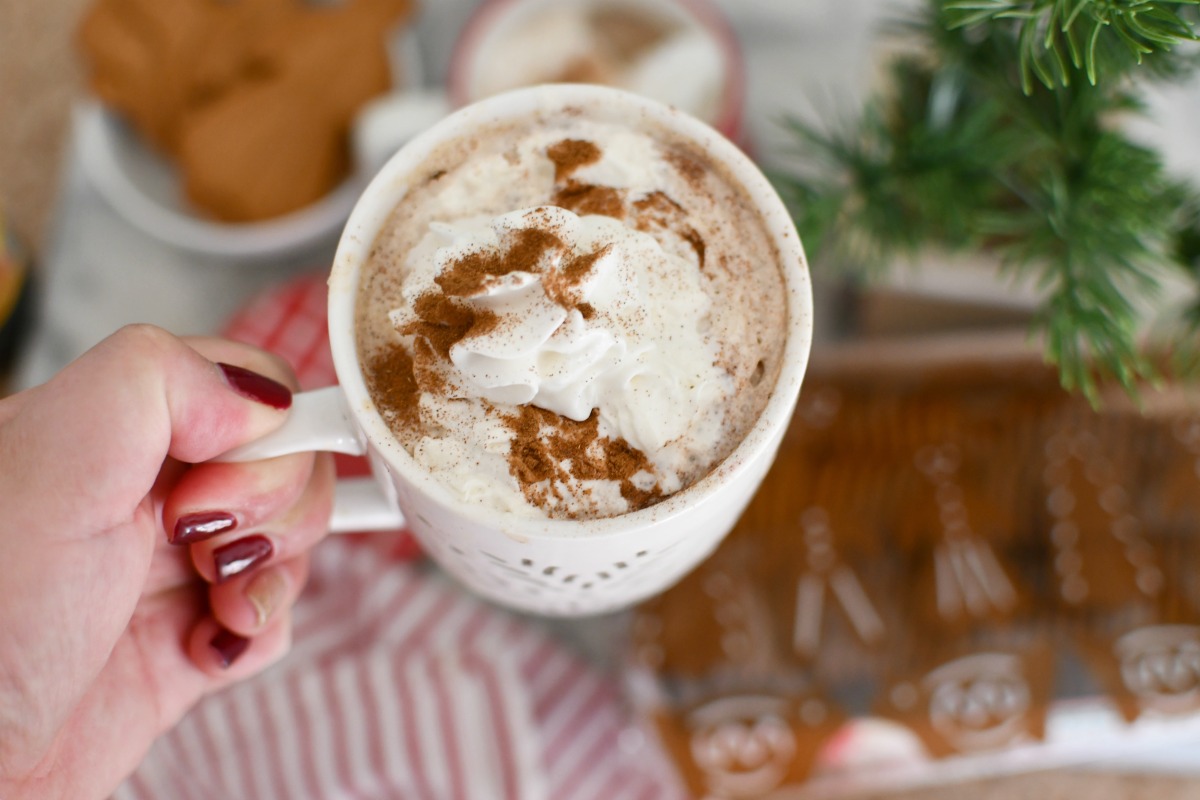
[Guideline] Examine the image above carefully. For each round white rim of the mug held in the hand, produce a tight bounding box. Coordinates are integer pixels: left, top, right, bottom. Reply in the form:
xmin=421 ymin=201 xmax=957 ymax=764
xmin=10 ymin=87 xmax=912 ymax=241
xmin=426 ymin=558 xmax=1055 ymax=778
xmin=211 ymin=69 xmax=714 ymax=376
xmin=328 ymin=84 xmax=812 ymax=539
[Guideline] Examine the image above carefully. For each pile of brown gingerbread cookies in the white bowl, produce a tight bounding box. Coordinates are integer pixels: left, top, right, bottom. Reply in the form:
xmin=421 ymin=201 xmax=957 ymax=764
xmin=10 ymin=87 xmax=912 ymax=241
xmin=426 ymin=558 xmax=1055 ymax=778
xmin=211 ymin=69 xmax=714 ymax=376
xmin=79 ymin=0 xmax=413 ymax=222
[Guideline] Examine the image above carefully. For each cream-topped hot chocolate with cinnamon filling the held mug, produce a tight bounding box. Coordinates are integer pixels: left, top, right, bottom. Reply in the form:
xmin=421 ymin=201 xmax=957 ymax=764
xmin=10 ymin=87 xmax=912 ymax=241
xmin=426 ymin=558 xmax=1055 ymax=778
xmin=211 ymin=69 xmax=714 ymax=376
xmin=355 ymin=109 xmax=787 ymax=519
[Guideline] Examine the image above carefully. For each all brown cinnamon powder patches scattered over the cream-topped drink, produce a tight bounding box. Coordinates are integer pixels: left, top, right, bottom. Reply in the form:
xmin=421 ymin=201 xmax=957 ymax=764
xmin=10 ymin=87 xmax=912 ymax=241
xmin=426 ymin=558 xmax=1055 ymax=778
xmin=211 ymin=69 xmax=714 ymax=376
xmin=368 ymin=131 xmax=707 ymax=518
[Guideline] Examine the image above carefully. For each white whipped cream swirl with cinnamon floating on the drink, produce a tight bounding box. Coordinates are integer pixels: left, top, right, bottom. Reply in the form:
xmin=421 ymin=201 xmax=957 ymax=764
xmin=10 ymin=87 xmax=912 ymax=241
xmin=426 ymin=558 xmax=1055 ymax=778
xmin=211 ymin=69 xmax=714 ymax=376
xmin=390 ymin=205 xmax=732 ymax=479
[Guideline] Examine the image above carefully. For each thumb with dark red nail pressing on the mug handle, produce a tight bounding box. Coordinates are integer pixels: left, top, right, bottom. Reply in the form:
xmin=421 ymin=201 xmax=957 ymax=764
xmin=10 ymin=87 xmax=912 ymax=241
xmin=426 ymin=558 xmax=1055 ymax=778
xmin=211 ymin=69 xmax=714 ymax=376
xmin=0 ymin=325 xmax=292 ymax=537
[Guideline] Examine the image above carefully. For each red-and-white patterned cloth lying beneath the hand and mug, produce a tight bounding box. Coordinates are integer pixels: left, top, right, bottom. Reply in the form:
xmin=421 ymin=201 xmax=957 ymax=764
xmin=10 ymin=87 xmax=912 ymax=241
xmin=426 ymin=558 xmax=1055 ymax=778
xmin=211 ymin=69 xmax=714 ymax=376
xmin=114 ymin=277 xmax=683 ymax=800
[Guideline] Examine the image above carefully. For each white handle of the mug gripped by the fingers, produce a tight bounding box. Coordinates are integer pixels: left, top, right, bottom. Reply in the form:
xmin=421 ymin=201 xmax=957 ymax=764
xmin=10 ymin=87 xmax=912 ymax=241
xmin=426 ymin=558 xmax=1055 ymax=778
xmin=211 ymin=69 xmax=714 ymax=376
xmin=214 ymin=386 xmax=404 ymax=534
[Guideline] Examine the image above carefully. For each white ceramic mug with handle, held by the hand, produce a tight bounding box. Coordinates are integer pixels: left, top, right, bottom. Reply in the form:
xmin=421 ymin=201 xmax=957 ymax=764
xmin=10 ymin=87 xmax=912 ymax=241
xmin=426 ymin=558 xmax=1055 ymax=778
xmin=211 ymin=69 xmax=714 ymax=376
xmin=226 ymin=84 xmax=812 ymax=615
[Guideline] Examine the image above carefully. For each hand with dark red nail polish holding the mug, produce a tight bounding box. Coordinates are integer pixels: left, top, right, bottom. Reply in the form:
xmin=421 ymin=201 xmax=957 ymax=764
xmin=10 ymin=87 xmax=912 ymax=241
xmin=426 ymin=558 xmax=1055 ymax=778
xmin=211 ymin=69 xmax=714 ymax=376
xmin=0 ymin=326 xmax=334 ymax=799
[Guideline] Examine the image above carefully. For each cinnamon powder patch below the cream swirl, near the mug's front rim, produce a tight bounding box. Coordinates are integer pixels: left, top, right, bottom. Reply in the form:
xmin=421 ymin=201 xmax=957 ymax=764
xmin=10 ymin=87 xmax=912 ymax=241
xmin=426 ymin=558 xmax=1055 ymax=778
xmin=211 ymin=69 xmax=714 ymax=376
xmin=506 ymin=405 xmax=662 ymax=520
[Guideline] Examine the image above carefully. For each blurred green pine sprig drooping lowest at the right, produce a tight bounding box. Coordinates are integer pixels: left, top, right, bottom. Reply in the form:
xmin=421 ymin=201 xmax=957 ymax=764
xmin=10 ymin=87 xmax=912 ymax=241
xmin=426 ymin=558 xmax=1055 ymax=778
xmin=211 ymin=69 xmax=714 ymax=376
xmin=996 ymin=132 xmax=1182 ymax=402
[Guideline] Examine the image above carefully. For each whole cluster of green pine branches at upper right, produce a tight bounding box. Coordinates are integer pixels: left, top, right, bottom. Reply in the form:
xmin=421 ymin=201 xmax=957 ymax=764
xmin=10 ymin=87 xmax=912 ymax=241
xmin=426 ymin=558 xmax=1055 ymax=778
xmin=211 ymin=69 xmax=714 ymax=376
xmin=776 ymin=0 xmax=1200 ymax=399
